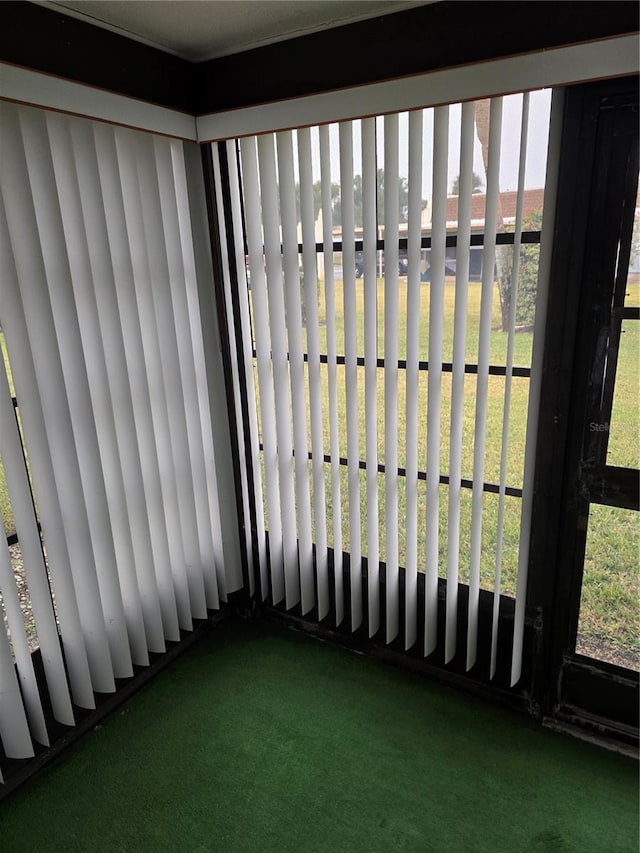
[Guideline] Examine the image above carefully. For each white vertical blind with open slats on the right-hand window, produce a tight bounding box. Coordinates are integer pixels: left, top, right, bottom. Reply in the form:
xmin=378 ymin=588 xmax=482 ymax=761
xmin=218 ymin=88 xmax=552 ymax=683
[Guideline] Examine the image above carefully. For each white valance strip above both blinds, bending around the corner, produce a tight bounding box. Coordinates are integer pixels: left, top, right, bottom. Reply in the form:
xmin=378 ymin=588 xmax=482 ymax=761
xmin=0 ymin=35 xmax=640 ymax=142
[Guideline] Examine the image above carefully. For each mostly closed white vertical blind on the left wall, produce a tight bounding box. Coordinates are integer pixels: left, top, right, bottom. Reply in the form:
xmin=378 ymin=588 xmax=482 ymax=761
xmin=0 ymin=103 xmax=242 ymax=772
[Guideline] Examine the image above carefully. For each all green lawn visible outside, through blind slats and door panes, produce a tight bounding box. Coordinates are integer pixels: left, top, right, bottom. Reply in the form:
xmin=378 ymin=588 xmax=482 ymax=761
xmin=248 ymin=278 xmax=640 ymax=651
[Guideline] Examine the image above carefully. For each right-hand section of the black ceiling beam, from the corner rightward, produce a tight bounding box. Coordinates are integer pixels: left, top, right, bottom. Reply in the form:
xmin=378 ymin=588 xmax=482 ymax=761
xmin=199 ymin=0 xmax=640 ymax=113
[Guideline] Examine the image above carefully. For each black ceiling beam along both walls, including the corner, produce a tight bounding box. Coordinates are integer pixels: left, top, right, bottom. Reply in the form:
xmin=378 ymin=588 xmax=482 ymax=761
xmin=0 ymin=0 xmax=640 ymax=115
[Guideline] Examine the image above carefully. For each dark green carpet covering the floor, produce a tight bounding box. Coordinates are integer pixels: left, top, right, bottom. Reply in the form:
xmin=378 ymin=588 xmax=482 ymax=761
xmin=0 ymin=622 xmax=638 ymax=853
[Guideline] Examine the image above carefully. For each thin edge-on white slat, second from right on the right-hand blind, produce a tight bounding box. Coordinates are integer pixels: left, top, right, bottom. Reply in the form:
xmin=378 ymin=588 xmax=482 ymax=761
xmin=490 ymin=92 xmax=529 ymax=678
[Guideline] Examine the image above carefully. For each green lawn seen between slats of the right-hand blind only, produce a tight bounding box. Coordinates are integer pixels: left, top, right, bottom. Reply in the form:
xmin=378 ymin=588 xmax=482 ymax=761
xmin=251 ymin=279 xmax=532 ymax=594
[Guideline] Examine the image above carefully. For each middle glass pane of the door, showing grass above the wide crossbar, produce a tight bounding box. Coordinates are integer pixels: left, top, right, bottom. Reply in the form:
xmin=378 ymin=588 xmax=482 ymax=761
xmin=607 ymin=320 xmax=640 ymax=468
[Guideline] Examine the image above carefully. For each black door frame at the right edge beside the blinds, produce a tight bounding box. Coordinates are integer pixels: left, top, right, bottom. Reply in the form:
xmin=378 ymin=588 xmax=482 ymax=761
xmin=527 ymin=77 xmax=638 ymax=744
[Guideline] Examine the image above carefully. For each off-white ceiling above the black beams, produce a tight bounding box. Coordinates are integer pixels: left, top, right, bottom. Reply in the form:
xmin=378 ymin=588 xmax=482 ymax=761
xmin=39 ymin=0 xmax=436 ymax=62
